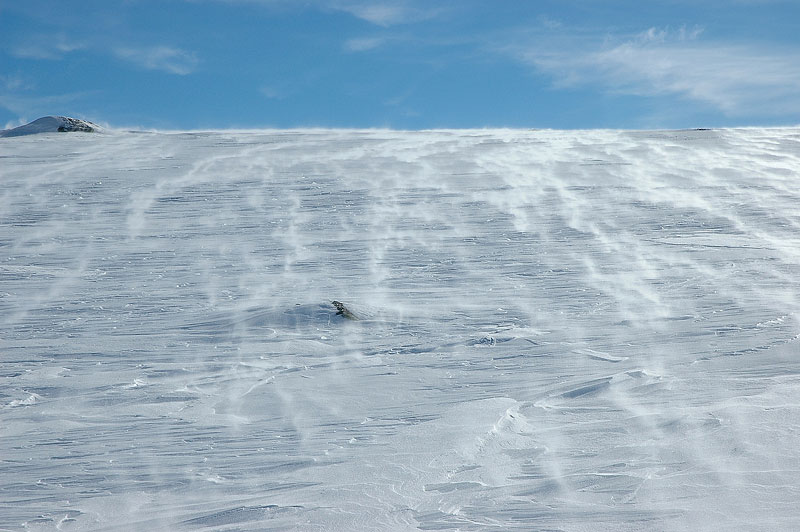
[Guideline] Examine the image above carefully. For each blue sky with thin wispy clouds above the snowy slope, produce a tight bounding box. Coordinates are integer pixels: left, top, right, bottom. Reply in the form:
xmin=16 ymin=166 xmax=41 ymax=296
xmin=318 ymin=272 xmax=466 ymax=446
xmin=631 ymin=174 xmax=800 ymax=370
xmin=0 ymin=0 xmax=800 ymax=129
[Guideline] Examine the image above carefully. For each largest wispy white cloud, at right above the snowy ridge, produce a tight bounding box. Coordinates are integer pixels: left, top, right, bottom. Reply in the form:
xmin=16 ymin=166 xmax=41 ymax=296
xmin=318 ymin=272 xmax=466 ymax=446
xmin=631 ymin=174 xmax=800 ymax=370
xmin=519 ymin=28 xmax=800 ymax=116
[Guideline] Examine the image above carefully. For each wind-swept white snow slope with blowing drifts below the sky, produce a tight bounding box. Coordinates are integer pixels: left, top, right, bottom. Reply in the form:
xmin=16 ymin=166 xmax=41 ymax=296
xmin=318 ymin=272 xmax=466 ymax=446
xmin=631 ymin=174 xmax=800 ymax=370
xmin=0 ymin=129 xmax=800 ymax=532
